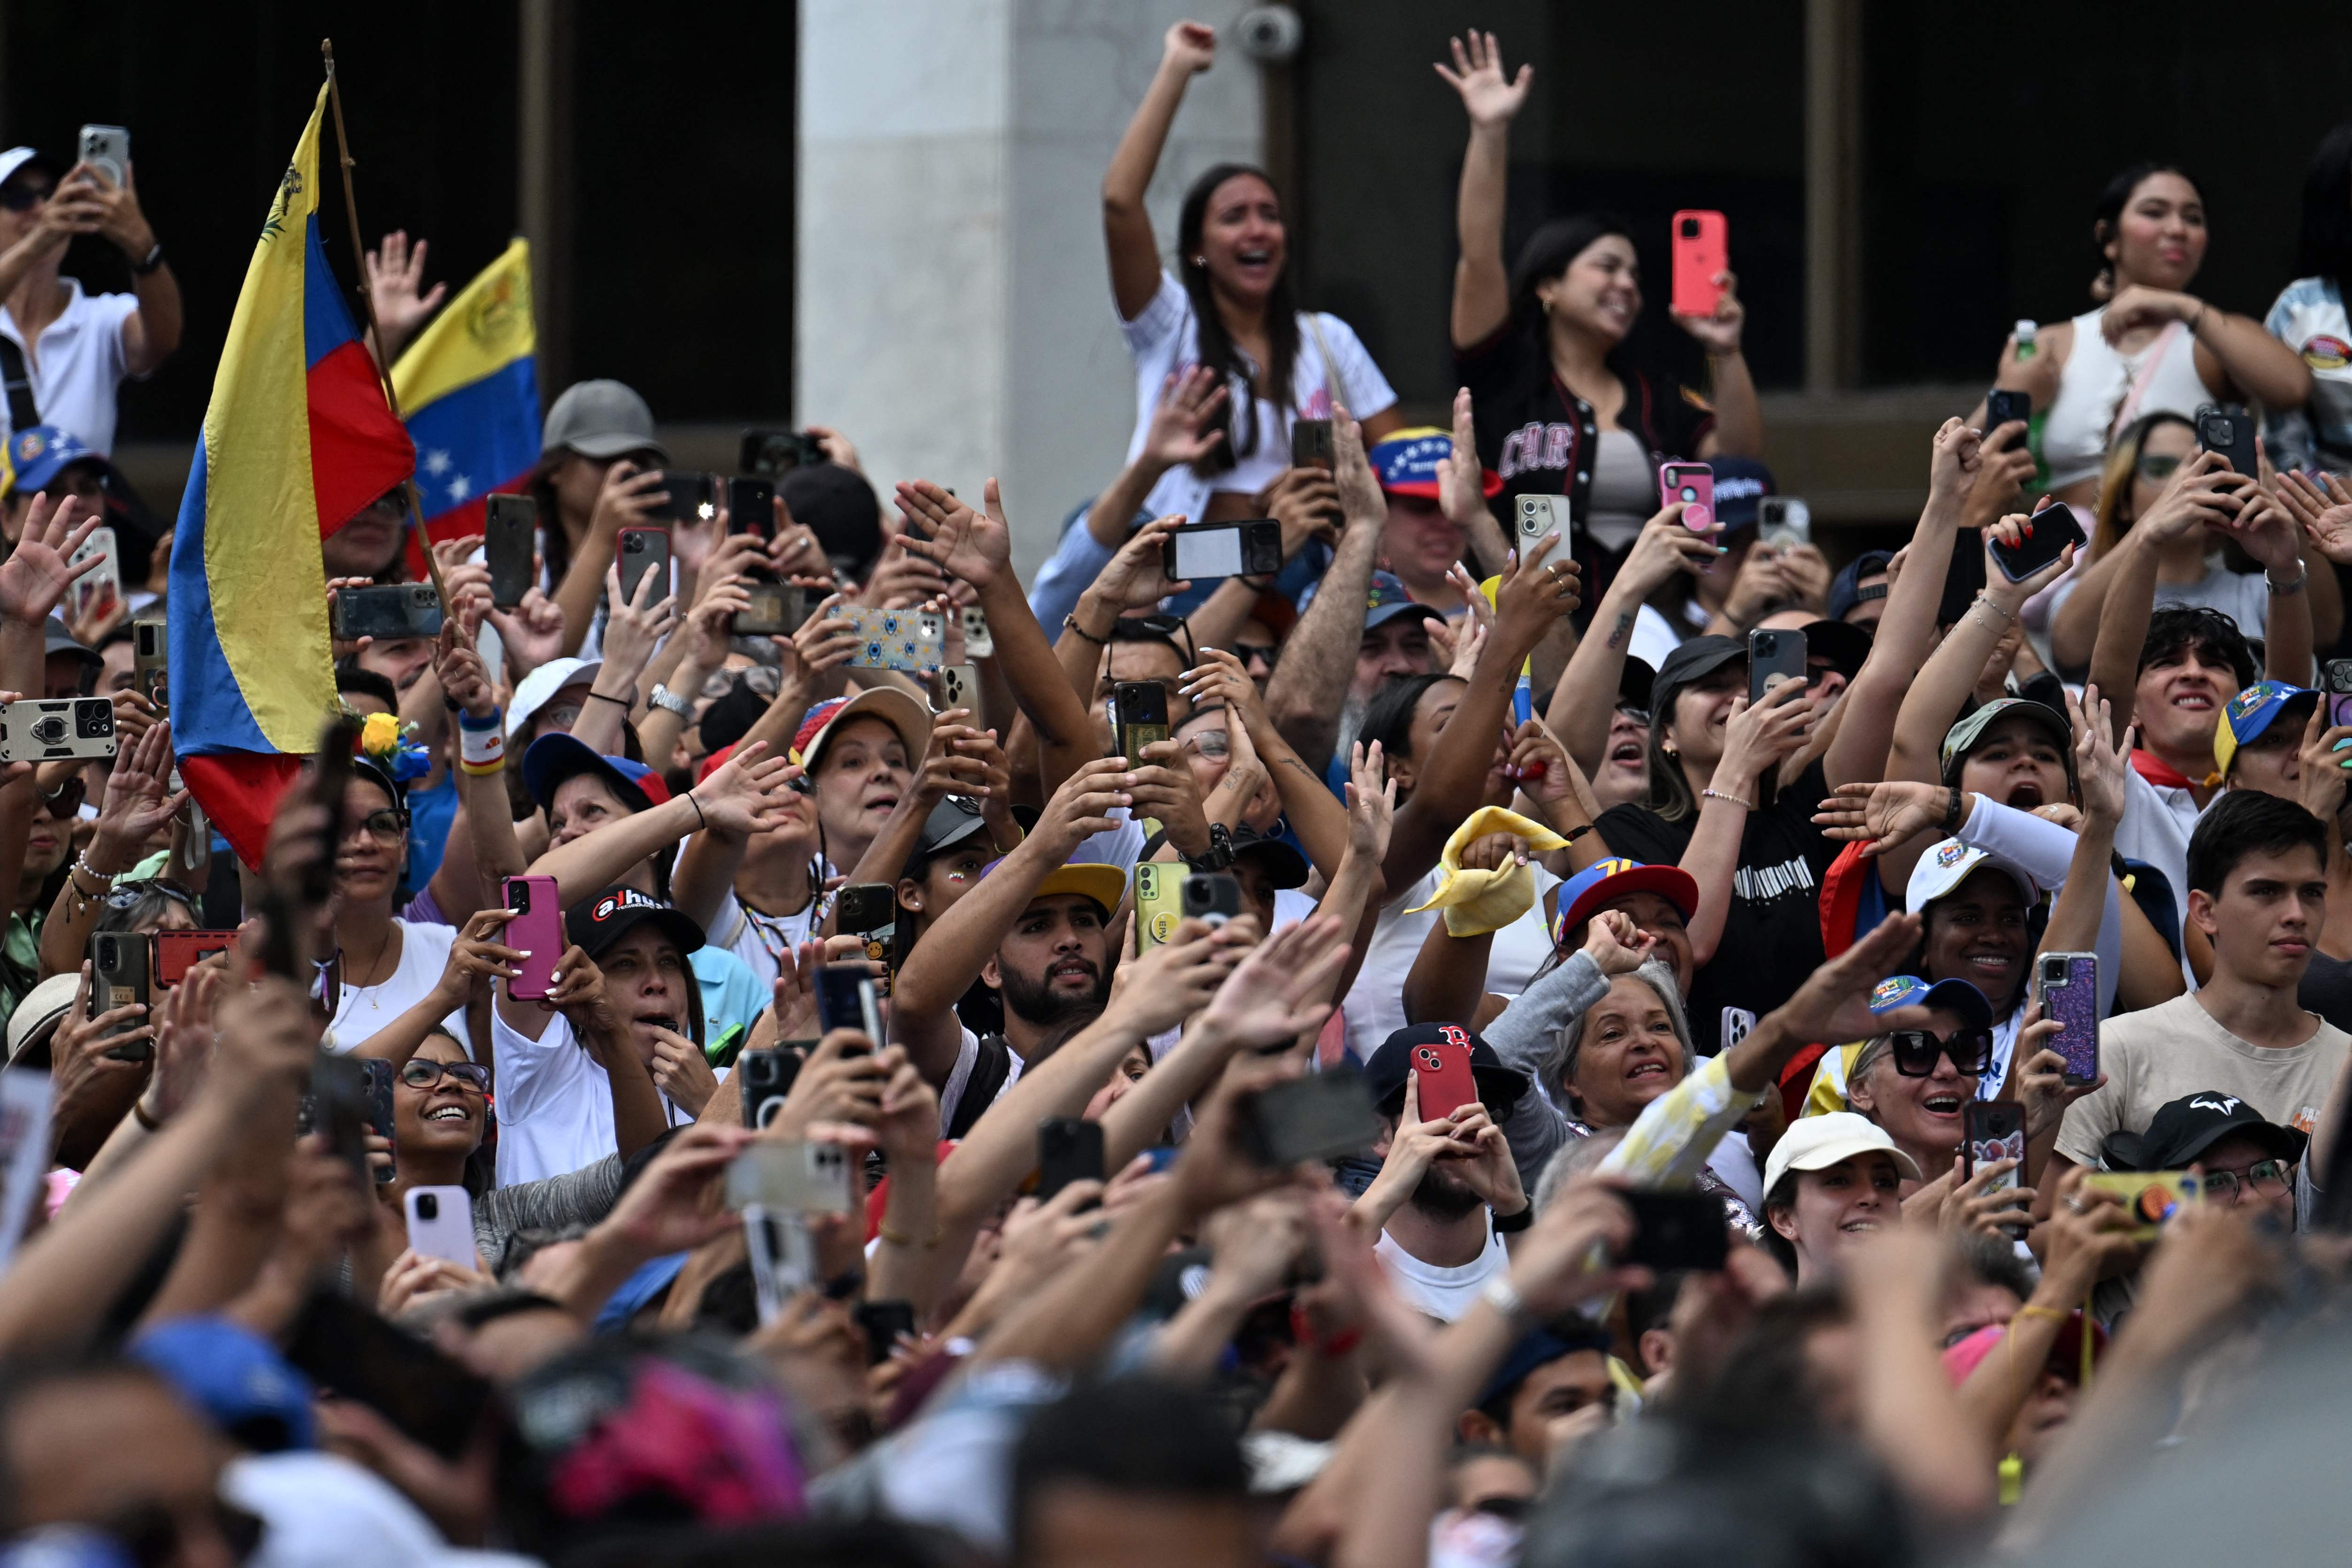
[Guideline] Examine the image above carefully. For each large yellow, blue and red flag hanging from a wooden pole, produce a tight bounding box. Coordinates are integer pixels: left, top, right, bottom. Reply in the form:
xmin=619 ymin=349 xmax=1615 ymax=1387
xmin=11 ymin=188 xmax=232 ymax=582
xmin=169 ymin=87 xmax=416 ymax=865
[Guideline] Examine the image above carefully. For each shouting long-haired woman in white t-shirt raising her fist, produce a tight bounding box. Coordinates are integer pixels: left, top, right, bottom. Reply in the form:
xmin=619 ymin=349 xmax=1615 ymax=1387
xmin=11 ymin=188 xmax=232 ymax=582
xmin=1103 ymin=21 xmax=1404 ymax=534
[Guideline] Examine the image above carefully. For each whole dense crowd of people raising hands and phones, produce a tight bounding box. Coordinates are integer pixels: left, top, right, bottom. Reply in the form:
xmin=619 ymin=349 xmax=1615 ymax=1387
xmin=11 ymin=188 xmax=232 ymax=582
xmin=0 ymin=23 xmax=2352 ymax=1568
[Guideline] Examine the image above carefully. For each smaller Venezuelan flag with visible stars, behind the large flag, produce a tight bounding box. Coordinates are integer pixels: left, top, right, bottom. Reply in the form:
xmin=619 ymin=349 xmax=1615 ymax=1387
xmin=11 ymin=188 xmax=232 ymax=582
xmin=393 ymin=240 xmax=539 ymax=552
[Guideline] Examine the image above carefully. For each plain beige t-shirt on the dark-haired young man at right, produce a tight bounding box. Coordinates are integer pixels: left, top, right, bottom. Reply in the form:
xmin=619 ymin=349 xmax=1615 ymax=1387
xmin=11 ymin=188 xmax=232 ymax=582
xmin=2058 ymin=994 xmax=2352 ymax=1166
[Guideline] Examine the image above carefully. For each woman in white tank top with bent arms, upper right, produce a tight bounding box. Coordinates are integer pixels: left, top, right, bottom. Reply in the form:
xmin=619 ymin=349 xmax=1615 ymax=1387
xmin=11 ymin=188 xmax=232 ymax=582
xmin=1969 ymin=162 xmax=2312 ymax=508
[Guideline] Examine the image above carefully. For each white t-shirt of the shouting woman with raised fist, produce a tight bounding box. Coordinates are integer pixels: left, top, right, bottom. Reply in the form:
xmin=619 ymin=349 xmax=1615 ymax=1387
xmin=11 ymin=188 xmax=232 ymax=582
xmin=1119 ymin=273 xmax=1397 ymax=522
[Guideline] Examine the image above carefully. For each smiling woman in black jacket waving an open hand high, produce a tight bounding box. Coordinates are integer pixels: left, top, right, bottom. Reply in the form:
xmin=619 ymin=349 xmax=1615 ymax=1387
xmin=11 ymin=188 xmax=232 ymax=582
xmin=1437 ymin=33 xmax=1764 ymax=602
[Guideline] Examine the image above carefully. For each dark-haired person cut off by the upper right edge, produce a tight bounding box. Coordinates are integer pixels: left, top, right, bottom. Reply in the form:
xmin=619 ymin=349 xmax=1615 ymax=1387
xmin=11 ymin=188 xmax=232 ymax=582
xmin=2263 ymin=120 xmax=2352 ymax=473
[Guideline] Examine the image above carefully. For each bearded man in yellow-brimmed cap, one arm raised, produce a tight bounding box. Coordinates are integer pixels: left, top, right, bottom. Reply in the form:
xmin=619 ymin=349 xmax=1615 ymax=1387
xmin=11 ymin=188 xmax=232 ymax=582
xmin=891 ymin=757 xmax=1134 ymax=1138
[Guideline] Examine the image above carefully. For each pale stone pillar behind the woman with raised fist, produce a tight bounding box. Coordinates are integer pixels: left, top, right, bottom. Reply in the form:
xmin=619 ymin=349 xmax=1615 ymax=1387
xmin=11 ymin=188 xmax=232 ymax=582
xmin=793 ymin=0 xmax=1261 ymax=574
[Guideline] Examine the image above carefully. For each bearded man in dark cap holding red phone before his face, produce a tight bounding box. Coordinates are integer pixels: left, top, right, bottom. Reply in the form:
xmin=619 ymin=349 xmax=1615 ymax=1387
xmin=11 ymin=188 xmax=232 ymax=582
xmin=1348 ymin=1023 xmax=1536 ymax=1323
